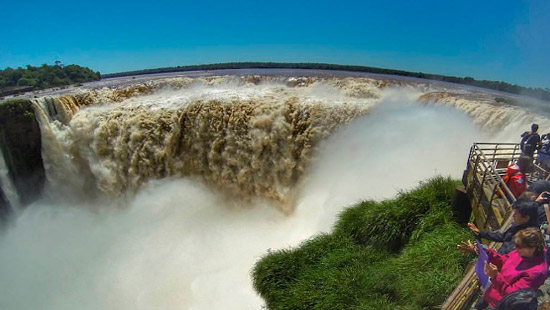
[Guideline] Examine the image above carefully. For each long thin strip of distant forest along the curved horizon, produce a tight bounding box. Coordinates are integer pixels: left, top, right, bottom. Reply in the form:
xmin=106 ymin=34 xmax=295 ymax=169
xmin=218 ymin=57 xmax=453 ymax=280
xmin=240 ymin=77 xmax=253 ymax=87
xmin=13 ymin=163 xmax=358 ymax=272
xmin=103 ymin=62 xmax=550 ymax=101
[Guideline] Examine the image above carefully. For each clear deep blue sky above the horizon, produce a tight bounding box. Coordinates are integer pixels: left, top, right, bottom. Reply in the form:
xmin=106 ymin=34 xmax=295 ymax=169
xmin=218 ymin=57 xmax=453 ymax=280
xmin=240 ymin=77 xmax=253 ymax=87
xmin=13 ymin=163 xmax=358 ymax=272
xmin=0 ymin=0 xmax=550 ymax=88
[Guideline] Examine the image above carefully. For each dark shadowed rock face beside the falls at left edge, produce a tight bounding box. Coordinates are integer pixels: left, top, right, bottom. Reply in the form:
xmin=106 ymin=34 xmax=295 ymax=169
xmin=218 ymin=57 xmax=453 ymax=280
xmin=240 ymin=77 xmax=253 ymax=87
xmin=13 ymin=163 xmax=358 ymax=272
xmin=0 ymin=100 xmax=45 ymax=213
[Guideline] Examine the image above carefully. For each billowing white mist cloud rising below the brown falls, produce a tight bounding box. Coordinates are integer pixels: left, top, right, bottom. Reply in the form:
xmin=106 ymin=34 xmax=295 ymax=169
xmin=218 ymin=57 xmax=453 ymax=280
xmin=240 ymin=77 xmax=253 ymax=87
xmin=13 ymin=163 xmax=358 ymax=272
xmin=0 ymin=87 xmax=488 ymax=310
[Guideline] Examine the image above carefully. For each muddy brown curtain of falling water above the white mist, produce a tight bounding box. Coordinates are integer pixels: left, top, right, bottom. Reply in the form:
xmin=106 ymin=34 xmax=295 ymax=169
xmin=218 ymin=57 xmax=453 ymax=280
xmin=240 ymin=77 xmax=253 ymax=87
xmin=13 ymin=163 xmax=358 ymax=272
xmin=29 ymin=76 xmax=381 ymax=212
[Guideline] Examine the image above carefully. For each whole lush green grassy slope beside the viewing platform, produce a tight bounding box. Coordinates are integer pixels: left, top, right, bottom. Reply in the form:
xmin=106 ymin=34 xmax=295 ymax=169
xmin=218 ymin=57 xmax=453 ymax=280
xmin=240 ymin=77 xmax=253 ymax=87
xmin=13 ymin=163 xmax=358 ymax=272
xmin=252 ymin=177 xmax=471 ymax=310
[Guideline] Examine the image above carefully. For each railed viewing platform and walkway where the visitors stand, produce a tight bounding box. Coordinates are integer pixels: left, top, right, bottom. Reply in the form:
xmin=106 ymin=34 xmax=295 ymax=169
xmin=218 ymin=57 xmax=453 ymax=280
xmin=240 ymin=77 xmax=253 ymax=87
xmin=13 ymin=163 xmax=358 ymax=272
xmin=442 ymin=143 xmax=549 ymax=310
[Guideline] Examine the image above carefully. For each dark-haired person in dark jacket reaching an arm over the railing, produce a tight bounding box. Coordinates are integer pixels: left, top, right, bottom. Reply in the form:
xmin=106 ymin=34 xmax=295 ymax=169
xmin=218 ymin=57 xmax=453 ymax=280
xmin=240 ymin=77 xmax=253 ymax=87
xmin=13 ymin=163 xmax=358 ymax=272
xmin=468 ymin=198 xmax=539 ymax=254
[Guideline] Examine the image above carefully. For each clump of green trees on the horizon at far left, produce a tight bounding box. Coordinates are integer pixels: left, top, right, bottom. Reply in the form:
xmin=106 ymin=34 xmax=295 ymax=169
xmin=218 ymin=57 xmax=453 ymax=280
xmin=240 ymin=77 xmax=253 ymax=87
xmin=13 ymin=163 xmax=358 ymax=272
xmin=0 ymin=61 xmax=101 ymax=96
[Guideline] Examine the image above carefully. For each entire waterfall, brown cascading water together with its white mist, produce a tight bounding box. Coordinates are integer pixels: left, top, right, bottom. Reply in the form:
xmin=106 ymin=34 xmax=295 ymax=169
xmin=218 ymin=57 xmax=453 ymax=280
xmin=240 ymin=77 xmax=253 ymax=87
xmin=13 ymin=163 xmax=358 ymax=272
xmin=0 ymin=76 xmax=550 ymax=310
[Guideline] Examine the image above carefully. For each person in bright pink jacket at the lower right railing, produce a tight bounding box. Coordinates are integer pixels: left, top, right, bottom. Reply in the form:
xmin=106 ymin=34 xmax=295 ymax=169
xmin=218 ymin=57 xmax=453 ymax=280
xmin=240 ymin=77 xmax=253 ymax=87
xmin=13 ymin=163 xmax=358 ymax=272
xmin=457 ymin=227 xmax=548 ymax=308
